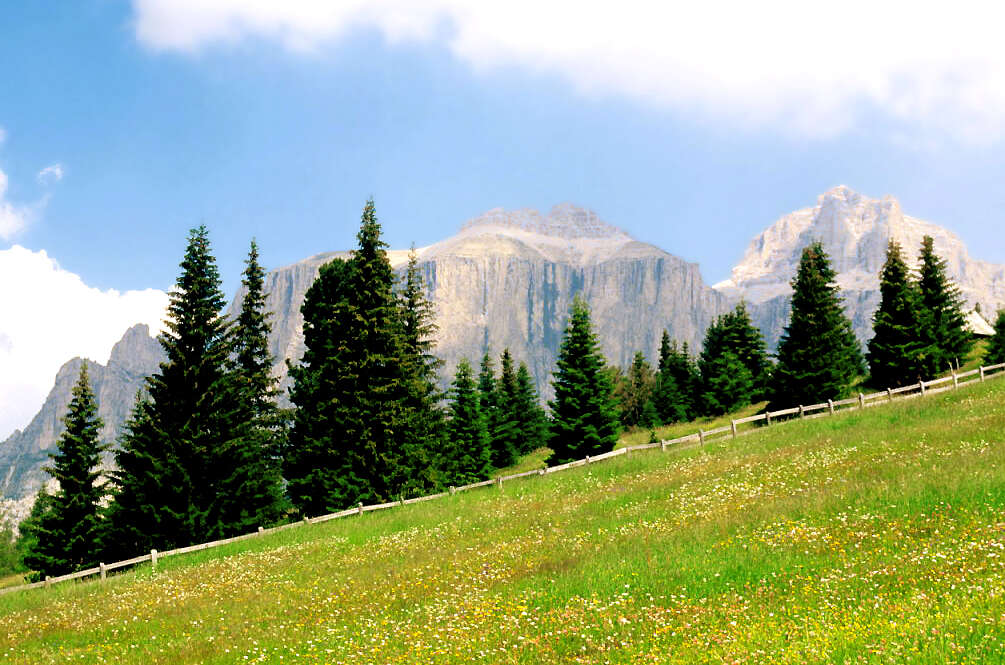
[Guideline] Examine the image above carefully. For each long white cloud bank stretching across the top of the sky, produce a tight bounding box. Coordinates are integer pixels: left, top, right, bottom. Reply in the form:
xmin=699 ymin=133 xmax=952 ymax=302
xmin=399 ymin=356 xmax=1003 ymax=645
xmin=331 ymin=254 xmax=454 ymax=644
xmin=134 ymin=0 xmax=1005 ymax=143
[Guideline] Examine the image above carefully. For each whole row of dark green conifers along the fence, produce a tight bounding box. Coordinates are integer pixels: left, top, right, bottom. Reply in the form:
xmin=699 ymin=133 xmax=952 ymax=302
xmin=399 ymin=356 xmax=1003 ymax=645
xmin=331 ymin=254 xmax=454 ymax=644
xmin=11 ymin=200 xmax=992 ymax=576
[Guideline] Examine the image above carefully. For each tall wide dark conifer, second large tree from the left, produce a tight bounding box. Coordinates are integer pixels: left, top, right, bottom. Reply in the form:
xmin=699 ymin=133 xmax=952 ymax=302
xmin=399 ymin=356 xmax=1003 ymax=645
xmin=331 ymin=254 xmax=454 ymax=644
xmin=109 ymin=226 xmax=272 ymax=556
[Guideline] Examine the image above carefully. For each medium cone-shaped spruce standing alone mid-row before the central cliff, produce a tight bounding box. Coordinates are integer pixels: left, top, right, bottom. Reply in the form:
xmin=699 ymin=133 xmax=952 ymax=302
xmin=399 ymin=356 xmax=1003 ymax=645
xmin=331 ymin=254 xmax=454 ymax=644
xmin=550 ymin=296 xmax=619 ymax=463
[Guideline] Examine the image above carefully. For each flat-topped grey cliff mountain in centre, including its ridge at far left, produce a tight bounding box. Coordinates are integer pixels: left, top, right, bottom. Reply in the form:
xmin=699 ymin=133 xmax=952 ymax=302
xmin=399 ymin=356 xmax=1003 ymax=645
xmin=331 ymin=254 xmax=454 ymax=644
xmin=0 ymin=204 xmax=730 ymax=498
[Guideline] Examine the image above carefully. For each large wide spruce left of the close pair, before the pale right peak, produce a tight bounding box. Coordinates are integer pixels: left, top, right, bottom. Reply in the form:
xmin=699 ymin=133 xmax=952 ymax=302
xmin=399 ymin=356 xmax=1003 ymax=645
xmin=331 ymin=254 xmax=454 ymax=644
xmin=771 ymin=242 xmax=862 ymax=409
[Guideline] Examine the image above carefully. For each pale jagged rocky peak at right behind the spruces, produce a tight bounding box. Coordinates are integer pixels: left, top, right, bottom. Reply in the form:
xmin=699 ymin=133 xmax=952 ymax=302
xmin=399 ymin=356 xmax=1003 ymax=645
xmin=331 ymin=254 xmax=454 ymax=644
xmin=715 ymin=186 xmax=1005 ymax=348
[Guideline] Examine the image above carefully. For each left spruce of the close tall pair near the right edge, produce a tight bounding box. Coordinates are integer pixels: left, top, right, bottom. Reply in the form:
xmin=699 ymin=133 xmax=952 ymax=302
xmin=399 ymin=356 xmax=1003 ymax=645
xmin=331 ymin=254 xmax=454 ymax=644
xmin=866 ymin=239 xmax=923 ymax=389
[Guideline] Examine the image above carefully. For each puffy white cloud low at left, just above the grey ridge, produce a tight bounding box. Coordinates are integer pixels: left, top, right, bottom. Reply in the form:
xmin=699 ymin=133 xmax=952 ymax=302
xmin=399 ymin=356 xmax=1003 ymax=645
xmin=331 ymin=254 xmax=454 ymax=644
xmin=0 ymin=245 xmax=168 ymax=440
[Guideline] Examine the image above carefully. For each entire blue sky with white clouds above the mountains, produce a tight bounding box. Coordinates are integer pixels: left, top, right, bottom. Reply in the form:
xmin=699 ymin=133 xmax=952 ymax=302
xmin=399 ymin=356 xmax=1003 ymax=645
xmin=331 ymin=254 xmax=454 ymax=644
xmin=0 ymin=0 xmax=1005 ymax=440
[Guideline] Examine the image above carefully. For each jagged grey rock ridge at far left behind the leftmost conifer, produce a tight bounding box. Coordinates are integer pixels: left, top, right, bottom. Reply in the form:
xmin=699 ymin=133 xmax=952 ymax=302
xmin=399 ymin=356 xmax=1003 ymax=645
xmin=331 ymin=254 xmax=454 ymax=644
xmin=0 ymin=324 xmax=163 ymax=507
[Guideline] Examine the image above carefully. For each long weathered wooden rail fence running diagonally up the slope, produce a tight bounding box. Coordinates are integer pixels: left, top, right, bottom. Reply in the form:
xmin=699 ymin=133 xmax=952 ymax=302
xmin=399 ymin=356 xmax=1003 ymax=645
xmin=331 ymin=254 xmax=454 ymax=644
xmin=0 ymin=363 xmax=1005 ymax=595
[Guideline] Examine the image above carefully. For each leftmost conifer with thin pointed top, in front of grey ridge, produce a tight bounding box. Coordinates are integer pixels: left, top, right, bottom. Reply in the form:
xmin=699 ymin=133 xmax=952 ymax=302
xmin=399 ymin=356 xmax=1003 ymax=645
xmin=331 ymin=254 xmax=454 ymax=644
xmin=22 ymin=362 xmax=107 ymax=577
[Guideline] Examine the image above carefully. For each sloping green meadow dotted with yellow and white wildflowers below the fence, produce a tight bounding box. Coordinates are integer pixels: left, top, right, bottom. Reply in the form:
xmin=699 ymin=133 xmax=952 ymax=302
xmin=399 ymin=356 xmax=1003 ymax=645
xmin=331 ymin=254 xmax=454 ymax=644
xmin=0 ymin=381 xmax=1005 ymax=665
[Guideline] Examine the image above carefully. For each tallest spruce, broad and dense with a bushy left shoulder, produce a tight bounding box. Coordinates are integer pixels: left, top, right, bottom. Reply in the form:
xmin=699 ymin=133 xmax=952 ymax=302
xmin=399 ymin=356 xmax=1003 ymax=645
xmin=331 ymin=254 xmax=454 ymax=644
xmin=284 ymin=200 xmax=414 ymax=514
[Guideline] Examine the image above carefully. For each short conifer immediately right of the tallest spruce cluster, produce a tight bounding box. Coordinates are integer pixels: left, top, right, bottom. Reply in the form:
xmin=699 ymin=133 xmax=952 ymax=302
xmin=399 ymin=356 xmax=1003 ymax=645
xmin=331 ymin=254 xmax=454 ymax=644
xmin=437 ymin=359 xmax=491 ymax=485
